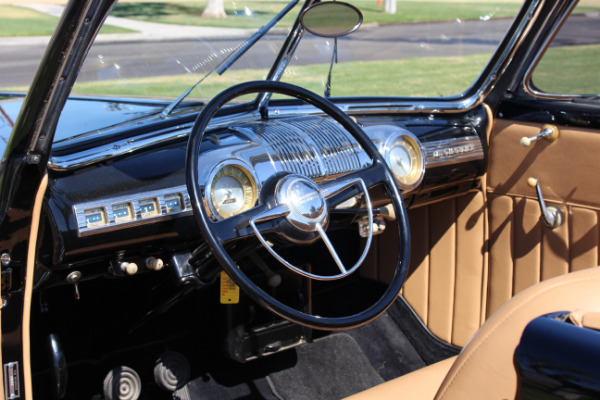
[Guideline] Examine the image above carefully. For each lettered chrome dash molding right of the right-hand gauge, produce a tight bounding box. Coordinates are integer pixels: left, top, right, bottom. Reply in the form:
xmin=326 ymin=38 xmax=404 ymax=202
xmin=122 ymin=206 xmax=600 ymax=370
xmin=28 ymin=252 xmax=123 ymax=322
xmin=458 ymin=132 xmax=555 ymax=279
xmin=423 ymin=136 xmax=485 ymax=168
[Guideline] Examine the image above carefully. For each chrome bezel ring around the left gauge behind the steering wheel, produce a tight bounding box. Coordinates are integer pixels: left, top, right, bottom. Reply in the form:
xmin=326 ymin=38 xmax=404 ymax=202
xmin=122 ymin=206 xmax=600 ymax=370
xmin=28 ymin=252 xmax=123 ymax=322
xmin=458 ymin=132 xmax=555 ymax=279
xmin=204 ymin=159 xmax=260 ymax=220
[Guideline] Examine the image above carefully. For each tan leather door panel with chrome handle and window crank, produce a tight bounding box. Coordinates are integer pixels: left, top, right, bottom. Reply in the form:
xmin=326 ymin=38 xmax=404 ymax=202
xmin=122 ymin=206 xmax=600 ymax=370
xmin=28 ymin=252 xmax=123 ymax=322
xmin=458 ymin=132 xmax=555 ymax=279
xmin=486 ymin=121 xmax=600 ymax=316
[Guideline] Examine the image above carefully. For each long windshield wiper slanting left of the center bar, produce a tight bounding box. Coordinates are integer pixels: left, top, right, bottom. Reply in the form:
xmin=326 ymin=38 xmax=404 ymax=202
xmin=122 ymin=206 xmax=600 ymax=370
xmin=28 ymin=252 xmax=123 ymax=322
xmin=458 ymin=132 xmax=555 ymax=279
xmin=160 ymin=0 xmax=300 ymax=119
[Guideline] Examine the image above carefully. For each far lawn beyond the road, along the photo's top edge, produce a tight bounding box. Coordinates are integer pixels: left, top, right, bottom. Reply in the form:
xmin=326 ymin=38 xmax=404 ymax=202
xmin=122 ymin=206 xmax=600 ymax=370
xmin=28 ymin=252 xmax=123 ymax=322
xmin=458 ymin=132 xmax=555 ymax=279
xmin=0 ymin=0 xmax=600 ymax=36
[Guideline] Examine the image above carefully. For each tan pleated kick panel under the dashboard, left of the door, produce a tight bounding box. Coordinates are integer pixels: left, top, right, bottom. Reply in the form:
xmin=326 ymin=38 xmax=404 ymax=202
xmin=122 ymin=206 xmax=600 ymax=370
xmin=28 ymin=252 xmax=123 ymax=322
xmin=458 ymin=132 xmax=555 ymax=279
xmin=403 ymin=192 xmax=486 ymax=346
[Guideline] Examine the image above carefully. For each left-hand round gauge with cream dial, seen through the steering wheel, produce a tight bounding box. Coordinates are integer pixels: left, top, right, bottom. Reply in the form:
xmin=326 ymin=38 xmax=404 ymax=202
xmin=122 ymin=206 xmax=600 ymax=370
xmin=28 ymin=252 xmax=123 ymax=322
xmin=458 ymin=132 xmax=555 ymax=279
xmin=209 ymin=164 xmax=257 ymax=218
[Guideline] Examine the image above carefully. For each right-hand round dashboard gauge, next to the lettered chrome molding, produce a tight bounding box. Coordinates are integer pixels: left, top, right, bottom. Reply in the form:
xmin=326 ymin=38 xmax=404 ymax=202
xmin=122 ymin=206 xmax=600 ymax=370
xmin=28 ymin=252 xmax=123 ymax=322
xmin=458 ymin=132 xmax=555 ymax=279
xmin=388 ymin=134 xmax=425 ymax=190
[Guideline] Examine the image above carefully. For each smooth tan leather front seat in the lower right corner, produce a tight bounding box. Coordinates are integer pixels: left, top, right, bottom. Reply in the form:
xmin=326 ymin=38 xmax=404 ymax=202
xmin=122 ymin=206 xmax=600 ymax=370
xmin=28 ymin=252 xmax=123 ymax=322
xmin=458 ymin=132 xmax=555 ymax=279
xmin=351 ymin=267 xmax=600 ymax=400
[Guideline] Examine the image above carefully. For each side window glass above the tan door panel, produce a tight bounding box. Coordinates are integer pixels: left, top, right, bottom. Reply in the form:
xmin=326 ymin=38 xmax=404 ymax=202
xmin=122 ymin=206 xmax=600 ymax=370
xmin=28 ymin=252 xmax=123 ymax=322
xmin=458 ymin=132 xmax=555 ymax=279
xmin=529 ymin=0 xmax=600 ymax=97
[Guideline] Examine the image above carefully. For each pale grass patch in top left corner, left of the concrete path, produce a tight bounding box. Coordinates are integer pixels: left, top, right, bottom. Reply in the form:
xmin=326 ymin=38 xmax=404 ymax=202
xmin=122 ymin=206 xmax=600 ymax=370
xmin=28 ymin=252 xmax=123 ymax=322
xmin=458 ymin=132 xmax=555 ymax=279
xmin=0 ymin=5 xmax=132 ymax=36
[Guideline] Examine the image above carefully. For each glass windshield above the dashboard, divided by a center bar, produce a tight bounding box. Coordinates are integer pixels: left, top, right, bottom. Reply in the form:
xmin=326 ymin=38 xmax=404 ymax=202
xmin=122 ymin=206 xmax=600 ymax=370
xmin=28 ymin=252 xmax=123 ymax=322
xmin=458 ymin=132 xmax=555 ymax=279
xmin=64 ymin=0 xmax=521 ymax=100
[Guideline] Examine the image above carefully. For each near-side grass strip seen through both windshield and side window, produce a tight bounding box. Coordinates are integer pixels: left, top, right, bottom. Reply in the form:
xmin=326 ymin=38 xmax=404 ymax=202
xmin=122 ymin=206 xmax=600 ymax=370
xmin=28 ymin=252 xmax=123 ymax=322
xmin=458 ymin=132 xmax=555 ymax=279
xmin=56 ymin=45 xmax=600 ymax=99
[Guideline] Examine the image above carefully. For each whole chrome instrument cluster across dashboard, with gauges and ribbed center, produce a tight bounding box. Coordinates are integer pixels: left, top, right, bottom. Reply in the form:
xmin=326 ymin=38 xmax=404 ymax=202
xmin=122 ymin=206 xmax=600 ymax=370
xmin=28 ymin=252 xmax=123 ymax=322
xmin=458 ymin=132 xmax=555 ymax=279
xmin=73 ymin=116 xmax=483 ymax=237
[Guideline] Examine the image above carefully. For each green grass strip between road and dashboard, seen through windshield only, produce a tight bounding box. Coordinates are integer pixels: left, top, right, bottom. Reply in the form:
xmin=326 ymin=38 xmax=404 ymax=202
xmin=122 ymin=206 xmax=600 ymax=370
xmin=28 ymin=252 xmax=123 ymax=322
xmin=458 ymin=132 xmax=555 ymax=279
xmin=58 ymin=50 xmax=489 ymax=99
